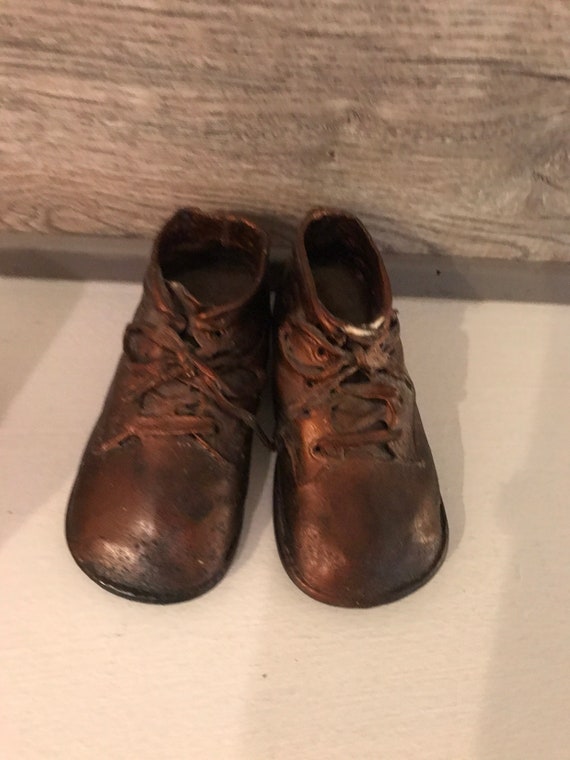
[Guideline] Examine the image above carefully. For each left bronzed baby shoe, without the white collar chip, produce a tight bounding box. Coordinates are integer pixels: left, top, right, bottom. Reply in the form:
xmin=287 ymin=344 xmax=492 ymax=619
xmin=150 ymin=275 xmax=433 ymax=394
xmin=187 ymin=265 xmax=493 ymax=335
xmin=67 ymin=209 xmax=269 ymax=604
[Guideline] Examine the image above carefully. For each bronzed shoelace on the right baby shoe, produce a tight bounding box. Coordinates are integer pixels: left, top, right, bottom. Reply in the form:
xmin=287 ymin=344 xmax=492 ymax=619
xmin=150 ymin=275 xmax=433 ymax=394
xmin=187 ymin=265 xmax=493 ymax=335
xmin=280 ymin=313 xmax=406 ymax=454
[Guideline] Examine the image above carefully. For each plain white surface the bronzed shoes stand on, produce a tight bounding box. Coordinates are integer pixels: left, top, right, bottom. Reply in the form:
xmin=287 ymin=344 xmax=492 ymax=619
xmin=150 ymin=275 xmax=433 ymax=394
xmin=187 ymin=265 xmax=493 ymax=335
xmin=0 ymin=279 xmax=570 ymax=760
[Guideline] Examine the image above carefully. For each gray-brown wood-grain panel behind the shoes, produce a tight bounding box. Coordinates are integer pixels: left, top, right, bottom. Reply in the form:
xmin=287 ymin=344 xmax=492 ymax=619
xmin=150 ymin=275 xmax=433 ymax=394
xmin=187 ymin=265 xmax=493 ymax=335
xmin=0 ymin=0 xmax=570 ymax=260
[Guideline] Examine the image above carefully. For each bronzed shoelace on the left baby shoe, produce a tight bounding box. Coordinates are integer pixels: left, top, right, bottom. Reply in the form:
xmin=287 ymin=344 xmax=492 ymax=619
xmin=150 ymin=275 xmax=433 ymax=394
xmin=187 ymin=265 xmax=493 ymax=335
xmin=101 ymin=314 xmax=274 ymax=458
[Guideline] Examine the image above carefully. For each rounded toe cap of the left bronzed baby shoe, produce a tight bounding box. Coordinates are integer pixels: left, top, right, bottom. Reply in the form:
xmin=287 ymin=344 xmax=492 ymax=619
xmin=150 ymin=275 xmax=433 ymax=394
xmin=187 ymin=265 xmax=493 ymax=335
xmin=66 ymin=442 xmax=241 ymax=604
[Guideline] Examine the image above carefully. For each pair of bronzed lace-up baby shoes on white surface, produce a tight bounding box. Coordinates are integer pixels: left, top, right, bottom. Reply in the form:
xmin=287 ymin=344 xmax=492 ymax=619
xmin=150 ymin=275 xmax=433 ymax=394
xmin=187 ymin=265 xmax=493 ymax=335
xmin=67 ymin=209 xmax=447 ymax=607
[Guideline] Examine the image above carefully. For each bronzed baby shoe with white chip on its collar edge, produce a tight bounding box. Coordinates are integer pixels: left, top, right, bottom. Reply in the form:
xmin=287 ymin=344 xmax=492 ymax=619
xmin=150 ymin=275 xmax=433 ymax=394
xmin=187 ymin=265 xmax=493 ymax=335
xmin=274 ymin=210 xmax=448 ymax=607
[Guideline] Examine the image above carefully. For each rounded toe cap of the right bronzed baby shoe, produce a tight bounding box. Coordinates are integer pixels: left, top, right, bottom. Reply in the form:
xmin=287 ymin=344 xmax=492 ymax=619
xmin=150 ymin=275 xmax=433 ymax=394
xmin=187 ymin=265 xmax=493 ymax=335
xmin=278 ymin=458 xmax=447 ymax=607
